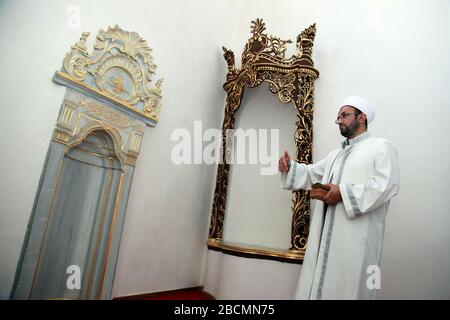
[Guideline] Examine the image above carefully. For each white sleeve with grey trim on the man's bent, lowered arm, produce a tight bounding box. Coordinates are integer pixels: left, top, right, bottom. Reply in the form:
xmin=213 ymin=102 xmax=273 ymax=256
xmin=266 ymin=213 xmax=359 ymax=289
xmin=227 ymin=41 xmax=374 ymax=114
xmin=339 ymin=141 xmax=400 ymax=218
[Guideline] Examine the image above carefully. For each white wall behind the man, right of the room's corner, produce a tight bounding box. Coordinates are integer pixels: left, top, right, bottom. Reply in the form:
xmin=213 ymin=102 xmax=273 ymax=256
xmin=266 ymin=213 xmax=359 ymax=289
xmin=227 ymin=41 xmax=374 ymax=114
xmin=205 ymin=0 xmax=450 ymax=299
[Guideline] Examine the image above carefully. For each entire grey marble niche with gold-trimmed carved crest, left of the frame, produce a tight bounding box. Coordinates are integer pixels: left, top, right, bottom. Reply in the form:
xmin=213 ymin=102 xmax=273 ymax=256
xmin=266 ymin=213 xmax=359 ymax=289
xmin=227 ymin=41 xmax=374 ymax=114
xmin=11 ymin=25 xmax=162 ymax=299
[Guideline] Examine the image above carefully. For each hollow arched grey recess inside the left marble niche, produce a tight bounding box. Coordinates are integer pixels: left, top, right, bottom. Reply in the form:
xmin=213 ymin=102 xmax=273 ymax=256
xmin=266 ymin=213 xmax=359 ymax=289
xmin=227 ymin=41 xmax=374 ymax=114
xmin=31 ymin=131 xmax=123 ymax=299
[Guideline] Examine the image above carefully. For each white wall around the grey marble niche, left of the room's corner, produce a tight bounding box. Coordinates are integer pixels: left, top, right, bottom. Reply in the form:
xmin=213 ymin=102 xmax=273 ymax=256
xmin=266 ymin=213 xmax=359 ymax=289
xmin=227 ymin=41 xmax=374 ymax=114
xmin=0 ymin=0 xmax=235 ymax=299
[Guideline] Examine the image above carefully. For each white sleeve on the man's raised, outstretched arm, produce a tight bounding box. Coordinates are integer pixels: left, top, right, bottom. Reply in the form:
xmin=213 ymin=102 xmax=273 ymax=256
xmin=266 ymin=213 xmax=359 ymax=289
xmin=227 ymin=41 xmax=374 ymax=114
xmin=281 ymin=159 xmax=327 ymax=190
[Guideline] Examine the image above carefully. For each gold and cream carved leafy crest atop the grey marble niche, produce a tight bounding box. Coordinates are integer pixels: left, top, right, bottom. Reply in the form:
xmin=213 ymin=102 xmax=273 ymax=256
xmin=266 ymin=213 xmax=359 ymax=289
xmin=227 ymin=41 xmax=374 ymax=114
xmin=63 ymin=25 xmax=162 ymax=119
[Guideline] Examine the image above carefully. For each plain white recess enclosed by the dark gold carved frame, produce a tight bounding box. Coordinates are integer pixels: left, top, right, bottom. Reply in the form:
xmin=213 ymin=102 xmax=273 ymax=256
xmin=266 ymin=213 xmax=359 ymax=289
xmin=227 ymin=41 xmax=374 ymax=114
xmin=223 ymin=83 xmax=297 ymax=251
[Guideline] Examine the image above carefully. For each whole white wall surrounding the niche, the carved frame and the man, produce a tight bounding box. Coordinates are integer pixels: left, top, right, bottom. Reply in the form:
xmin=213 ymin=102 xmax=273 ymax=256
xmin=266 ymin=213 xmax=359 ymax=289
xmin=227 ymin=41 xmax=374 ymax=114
xmin=0 ymin=0 xmax=450 ymax=299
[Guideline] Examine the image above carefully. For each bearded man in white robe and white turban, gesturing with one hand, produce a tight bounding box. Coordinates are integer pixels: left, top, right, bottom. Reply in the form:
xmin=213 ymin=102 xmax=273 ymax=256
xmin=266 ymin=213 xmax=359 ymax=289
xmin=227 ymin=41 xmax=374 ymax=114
xmin=279 ymin=96 xmax=399 ymax=299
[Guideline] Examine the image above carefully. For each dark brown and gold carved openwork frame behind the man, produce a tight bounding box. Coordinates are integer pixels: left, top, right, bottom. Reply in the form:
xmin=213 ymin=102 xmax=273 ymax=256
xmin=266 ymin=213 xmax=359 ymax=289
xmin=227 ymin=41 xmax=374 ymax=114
xmin=208 ymin=19 xmax=319 ymax=263
